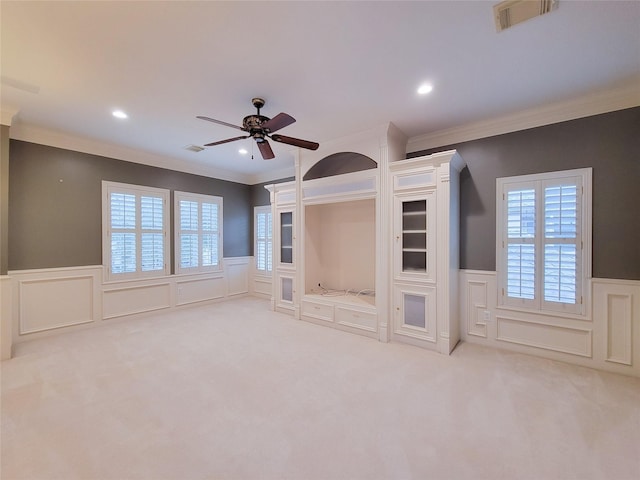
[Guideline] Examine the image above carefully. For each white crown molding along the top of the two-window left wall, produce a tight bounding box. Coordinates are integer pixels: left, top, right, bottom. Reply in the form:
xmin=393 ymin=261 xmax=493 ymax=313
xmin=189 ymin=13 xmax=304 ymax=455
xmin=10 ymin=122 xmax=250 ymax=185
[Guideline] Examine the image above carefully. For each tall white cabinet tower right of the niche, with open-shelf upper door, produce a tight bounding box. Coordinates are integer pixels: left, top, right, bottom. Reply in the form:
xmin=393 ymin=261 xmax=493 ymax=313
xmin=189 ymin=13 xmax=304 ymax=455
xmin=389 ymin=151 xmax=464 ymax=354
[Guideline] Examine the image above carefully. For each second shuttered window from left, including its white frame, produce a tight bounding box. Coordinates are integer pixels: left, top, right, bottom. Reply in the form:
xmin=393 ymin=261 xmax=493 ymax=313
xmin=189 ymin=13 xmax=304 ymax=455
xmin=175 ymin=192 xmax=222 ymax=273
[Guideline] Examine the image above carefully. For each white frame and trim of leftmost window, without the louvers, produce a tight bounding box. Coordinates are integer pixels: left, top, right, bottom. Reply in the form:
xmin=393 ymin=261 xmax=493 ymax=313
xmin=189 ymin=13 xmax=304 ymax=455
xmin=102 ymin=180 xmax=171 ymax=282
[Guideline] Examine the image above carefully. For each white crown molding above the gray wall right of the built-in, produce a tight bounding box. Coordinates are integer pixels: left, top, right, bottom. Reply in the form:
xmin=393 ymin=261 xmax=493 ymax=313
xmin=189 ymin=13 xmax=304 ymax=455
xmin=407 ymin=82 xmax=640 ymax=153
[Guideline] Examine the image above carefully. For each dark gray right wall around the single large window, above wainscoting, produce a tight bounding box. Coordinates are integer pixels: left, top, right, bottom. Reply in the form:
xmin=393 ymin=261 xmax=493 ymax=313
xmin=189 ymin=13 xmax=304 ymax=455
xmin=409 ymin=107 xmax=640 ymax=280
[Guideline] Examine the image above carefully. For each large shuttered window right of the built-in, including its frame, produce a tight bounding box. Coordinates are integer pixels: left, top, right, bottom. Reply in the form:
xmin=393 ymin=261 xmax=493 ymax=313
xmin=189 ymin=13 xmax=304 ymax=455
xmin=496 ymin=168 xmax=591 ymax=315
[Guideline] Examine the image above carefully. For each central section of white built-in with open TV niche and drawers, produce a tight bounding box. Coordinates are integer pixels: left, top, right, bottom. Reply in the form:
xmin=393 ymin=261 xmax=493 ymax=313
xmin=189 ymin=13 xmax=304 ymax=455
xmin=298 ymin=169 xmax=379 ymax=338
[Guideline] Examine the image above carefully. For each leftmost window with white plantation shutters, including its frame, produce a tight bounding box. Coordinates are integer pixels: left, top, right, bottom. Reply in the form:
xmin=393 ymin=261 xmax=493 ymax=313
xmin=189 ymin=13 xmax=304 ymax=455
xmin=102 ymin=182 xmax=169 ymax=280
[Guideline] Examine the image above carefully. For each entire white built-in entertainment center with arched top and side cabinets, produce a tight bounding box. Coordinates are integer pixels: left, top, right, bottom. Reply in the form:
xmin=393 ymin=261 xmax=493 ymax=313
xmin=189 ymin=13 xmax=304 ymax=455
xmin=267 ymin=125 xmax=464 ymax=354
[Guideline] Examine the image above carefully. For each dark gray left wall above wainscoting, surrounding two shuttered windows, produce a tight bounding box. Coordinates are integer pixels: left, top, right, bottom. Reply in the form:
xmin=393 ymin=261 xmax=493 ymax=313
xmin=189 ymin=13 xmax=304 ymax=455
xmin=8 ymin=140 xmax=253 ymax=272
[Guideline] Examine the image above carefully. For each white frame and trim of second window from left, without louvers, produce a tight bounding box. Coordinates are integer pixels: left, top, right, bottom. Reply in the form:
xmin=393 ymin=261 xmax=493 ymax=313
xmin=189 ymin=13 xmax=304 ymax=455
xmin=173 ymin=191 xmax=224 ymax=275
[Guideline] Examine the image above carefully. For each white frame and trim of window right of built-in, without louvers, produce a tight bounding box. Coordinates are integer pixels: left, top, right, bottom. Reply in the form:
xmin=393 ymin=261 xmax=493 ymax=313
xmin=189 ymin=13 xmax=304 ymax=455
xmin=496 ymin=168 xmax=592 ymax=320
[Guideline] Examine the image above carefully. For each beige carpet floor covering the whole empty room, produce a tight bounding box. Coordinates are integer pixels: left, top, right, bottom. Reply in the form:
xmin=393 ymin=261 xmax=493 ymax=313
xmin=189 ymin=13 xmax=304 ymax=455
xmin=1 ymin=298 xmax=640 ymax=480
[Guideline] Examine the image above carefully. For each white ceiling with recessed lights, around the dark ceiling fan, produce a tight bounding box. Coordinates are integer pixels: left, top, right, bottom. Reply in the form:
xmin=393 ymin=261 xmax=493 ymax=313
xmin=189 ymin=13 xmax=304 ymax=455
xmin=0 ymin=0 xmax=640 ymax=179
